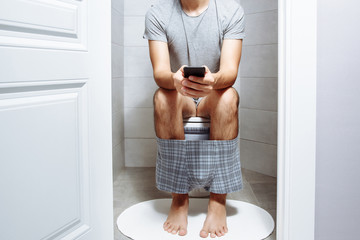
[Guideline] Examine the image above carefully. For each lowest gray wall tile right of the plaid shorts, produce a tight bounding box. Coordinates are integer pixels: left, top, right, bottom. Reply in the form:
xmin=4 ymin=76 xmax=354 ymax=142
xmin=240 ymin=139 xmax=277 ymax=177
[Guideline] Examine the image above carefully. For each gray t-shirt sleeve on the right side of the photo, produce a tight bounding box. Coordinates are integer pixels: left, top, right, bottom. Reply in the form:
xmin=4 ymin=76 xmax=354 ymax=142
xmin=224 ymin=6 xmax=245 ymax=39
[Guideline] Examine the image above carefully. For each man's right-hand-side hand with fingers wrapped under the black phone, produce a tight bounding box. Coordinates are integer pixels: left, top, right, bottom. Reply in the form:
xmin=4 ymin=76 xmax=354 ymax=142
xmin=181 ymin=66 xmax=215 ymax=98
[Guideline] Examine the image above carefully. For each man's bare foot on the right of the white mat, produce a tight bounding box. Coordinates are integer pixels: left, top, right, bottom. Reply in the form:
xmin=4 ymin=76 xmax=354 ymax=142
xmin=200 ymin=193 xmax=228 ymax=238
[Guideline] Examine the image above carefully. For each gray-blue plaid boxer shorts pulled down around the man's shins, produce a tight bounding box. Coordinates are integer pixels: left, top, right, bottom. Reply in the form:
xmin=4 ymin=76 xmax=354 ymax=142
xmin=156 ymin=138 xmax=242 ymax=194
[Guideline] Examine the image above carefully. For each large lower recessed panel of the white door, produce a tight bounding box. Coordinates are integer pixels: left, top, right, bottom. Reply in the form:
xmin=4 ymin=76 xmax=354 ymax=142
xmin=0 ymin=80 xmax=89 ymax=239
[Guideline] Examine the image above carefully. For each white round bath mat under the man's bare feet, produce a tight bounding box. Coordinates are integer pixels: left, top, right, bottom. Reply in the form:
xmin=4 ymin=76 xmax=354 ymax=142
xmin=117 ymin=198 xmax=275 ymax=240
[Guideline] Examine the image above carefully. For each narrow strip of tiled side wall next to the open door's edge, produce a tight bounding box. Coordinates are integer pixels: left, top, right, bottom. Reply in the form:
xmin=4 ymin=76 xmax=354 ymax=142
xmin=111 ymin=0 xmax=125 ymax=178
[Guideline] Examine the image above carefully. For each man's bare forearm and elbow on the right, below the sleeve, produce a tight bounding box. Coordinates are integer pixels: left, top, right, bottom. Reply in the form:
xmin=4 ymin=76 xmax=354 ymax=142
xmin=213 ymin=39 xmax=242 ymax=89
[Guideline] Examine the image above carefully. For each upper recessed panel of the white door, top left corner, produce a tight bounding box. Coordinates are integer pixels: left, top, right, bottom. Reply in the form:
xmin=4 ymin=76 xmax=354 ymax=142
xmin=0 ymin=0 xmax=87 ymax=51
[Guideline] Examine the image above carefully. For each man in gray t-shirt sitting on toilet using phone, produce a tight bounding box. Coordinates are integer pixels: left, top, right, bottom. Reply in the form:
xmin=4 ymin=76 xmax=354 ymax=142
xmin=144 ymin=0 xmax=244 ymax=238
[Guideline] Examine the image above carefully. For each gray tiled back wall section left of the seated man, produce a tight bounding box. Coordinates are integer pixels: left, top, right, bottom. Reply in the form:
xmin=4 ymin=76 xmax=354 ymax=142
xmin=124 ymin=0 xmax=157 ymax=167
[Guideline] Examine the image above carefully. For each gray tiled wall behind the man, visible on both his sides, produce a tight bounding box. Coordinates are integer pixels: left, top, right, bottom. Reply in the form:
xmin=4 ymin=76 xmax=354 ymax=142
xmin=123 ymin=0 xmax=278 ymax=176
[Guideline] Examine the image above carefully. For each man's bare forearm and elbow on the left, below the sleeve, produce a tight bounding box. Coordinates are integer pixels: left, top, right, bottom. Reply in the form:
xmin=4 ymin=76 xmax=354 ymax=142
xmin=149 ymin=40 xmax=175 ymax=89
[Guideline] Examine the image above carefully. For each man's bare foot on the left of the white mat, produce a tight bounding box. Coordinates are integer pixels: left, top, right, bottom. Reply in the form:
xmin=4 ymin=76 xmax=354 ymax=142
xmin=164 ymin=193 xmax=189 ymax=236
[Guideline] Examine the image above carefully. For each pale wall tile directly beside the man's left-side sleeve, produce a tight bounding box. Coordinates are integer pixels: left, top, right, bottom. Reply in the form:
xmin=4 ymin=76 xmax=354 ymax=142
xmin=124 ymin=16 xmax=148 ymax=47
